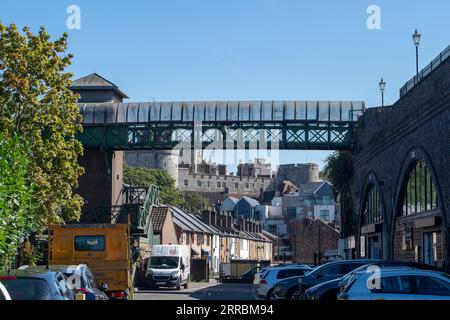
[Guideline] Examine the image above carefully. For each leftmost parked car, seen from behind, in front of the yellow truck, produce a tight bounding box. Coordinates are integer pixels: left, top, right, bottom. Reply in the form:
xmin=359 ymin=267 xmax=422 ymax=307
xmin=0 ymin=267 xmax=75 ymax=300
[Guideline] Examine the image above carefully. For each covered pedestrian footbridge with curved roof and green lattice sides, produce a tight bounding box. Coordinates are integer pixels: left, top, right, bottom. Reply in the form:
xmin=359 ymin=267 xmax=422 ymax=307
xmin=78 ymin=101 xmax=365 ymax=150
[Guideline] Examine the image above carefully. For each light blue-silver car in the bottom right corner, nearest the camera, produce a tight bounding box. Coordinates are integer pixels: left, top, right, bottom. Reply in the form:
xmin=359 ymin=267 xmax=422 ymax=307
xmin=338 ymin=267 xmax=450 ymax=300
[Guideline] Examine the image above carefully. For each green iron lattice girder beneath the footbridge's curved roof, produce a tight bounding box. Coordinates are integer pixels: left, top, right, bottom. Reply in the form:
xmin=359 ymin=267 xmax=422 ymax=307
xmin=78 ymin=121 xmax=356 ymax=150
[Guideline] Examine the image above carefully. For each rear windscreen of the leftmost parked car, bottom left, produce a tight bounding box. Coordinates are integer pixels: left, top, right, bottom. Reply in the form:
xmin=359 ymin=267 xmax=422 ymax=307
xmin=1 ymin=278 xmax=51 ymax=300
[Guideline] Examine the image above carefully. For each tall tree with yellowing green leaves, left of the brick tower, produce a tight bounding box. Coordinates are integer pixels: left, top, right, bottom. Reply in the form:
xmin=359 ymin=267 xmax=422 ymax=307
xmin=0 ymin=23 xmax=83 ymax=228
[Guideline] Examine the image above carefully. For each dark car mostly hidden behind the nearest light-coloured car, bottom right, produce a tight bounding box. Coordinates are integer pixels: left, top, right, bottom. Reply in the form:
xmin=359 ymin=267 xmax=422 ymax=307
xmin=297 ymin=261 xmax=450 ymax=300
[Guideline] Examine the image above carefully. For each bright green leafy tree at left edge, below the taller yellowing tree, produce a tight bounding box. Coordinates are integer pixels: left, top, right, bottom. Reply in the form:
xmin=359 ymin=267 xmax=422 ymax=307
xmin=0 ymin=133 xmax=36 ymax=268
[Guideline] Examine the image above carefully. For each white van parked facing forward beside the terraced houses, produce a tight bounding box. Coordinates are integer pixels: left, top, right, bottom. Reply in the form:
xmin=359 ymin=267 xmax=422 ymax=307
xmin=145 ymin=244 xmax=191 ymax=290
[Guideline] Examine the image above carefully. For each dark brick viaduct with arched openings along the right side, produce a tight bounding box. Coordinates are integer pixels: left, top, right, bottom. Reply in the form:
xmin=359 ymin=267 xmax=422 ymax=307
xmin=347 ymin=50 xmax=450 ymax=267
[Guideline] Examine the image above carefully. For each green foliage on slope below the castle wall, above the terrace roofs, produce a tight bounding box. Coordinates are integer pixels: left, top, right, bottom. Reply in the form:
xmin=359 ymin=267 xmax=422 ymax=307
xmin=123 ymin=165 xmax=209 ymax=212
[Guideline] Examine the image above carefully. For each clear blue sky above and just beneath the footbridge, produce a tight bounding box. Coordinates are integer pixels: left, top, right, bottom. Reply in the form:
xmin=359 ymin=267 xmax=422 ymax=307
xmin=0 ymin=0 xmax=450 ymax=172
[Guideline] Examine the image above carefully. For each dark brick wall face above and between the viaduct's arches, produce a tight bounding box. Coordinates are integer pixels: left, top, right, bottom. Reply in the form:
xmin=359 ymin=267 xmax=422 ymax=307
xmin=352 ymin=52 xmax=450 ymax=259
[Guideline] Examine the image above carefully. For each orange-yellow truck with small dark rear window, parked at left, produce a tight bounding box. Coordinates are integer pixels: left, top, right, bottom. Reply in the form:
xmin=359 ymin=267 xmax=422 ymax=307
xmin=48 ymin=224 xmax=133 ymax=299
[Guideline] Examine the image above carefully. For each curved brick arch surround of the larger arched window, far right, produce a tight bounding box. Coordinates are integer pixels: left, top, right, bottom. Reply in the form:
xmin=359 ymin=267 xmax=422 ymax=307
xmin=390 ymin=146 xmax=449 ymax=263
